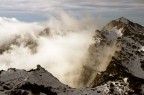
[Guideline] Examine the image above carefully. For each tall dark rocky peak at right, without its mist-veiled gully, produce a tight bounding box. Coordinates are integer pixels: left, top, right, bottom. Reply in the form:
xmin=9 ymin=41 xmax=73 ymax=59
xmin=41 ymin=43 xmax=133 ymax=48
xmin=89 ymin=18 xmax=144 ymax=95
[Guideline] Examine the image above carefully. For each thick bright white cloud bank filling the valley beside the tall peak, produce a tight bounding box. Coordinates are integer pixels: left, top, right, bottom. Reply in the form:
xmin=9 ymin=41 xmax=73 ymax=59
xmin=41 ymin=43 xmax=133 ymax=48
xmin=0 ymin=13 xmax=107 ymax=87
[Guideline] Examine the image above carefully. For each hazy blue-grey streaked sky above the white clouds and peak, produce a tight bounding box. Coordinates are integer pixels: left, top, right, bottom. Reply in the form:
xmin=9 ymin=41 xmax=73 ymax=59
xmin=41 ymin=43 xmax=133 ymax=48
xmin=0 ymin=0 xmax=144 ymax=24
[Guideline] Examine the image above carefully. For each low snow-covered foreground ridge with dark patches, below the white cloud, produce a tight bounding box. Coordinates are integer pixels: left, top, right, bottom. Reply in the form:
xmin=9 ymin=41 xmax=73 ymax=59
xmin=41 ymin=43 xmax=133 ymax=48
xmin=0 ymin=65 xmax=129 ymax=95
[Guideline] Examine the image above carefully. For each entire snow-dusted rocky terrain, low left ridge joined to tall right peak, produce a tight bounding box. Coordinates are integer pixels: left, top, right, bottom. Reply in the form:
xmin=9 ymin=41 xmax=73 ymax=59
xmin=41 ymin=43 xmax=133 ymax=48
xmin=0 ymin=17 xmax=144 ymax=95
